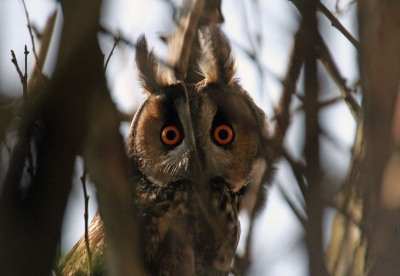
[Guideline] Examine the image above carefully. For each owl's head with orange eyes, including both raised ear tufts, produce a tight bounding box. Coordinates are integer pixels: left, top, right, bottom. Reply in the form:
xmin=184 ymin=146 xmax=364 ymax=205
xmin=127 ymin=26 xmax=267 ymax=191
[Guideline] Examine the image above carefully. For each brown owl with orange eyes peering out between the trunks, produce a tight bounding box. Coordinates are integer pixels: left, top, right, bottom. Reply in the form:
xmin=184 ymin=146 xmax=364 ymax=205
xmin=59 ymin=26 xmax=270 ymax=276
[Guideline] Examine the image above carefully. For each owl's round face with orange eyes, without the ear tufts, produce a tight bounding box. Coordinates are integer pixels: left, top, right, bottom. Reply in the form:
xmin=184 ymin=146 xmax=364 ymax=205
xmin=131 ymin=81 xmax=264 ymax=191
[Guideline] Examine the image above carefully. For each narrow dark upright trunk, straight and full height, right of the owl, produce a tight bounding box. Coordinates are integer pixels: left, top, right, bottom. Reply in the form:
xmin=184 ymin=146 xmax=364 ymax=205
xmin=303 ymin=0 xmax=326 ymax=276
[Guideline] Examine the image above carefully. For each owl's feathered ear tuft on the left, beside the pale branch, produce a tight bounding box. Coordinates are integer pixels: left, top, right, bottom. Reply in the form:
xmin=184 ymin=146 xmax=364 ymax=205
xmin=135 ymin=35 xmax=172 ymax=93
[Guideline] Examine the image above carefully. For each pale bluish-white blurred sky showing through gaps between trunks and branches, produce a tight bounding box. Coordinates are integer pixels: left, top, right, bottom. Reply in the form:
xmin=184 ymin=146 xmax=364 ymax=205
xmin=0 ymin=0 xmax=361 ymax=276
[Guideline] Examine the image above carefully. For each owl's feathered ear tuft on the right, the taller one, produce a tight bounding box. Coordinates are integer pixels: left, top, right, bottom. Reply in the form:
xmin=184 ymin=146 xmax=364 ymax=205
xmin=199 ymin=24 xmax=236 ymax=85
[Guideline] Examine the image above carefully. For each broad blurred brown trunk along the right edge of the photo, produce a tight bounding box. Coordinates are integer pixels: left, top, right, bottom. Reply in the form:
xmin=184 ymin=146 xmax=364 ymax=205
xmin=355 ymin=0 xmax=400 ymax=275
